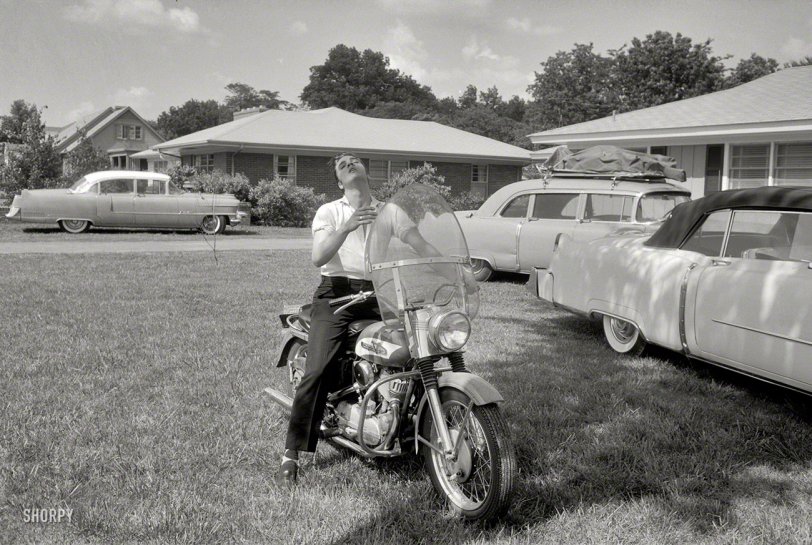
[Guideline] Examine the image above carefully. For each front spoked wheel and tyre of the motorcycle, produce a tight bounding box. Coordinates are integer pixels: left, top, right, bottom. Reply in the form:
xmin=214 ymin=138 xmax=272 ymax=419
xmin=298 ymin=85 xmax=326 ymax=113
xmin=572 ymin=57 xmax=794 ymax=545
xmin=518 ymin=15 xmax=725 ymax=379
xmin=423 ymin=389 xmax=516 ymax=520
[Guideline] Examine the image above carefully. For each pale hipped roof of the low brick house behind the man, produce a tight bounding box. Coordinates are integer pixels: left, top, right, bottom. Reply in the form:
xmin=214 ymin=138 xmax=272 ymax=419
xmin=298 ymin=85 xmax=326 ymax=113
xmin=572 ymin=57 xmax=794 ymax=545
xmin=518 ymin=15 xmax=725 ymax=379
xmin=153 ymin=108 xmax=530 ymax=164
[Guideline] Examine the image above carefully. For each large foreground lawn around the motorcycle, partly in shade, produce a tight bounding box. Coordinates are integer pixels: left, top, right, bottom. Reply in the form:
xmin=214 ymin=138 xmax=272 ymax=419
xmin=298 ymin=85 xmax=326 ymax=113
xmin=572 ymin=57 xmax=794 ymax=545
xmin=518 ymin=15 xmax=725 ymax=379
xmin=0 ymin=251 xmax=812 ymax=544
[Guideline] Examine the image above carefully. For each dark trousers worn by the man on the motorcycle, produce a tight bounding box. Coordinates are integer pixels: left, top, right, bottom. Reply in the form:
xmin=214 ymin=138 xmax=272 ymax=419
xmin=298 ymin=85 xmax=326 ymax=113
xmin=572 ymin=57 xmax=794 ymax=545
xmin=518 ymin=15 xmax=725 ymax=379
xmin=285 ymin=276 xmax=381 ymax=452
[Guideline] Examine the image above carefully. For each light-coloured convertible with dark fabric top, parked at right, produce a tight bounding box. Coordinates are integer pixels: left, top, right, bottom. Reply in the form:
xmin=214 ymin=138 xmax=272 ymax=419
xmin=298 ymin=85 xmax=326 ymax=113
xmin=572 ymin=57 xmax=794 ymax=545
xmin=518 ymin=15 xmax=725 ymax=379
xmin=528 ymin=187 xmax=812 ymax=393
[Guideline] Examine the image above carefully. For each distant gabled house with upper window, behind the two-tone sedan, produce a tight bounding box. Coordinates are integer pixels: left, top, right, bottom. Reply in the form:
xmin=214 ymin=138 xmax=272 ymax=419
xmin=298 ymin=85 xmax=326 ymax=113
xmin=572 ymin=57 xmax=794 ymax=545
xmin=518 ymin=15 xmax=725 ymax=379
xmin=51 ymin=106 xmax=164 ymax=170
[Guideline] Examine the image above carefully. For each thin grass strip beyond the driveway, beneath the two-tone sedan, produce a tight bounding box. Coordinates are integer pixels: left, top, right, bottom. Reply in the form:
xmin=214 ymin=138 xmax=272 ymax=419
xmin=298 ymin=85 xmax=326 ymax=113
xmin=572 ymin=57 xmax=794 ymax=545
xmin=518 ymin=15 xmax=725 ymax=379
xmin=0 ymin=216 xmax=311 ymax=242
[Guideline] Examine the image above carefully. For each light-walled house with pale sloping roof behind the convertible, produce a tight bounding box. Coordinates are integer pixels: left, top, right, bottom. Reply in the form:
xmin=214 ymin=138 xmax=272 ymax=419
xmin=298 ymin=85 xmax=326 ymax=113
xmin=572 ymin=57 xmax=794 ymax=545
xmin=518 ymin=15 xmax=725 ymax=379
xmin=529 ymin=66 xmax=812 ymax=197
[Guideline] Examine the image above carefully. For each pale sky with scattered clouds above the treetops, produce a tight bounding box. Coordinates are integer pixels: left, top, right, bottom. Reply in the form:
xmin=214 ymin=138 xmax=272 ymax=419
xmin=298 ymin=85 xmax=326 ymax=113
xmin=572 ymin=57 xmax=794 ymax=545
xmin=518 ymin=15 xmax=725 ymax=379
xmin=0 ymin=0 xmax=812 ymax=126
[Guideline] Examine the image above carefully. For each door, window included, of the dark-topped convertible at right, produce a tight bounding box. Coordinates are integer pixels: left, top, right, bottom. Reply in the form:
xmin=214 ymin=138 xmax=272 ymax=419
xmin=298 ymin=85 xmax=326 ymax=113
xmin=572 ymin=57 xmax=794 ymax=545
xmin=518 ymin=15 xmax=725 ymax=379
xmin=694 ymin=211 xmax=812 ymax=389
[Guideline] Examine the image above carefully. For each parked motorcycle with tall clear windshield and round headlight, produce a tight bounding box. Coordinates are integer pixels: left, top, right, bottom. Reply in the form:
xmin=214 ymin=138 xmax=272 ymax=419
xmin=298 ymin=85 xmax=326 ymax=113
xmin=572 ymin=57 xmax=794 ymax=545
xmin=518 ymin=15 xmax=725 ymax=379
xmin=265 ymin=184 xmax=516 ymax=520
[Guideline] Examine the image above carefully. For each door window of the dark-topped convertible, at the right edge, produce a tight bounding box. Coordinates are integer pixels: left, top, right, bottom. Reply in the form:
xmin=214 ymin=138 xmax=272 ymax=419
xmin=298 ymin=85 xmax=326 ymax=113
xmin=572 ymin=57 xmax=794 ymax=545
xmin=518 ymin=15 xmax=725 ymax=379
xmin=725 ymin=210 xmax=812 ymax=261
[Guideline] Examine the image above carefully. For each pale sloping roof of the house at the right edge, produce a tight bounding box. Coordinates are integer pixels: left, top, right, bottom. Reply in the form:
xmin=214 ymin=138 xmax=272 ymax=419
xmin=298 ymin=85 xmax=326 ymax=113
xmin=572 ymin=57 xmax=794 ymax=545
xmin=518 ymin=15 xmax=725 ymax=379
xmin=529 ymin=66 xmax=812 ymax=144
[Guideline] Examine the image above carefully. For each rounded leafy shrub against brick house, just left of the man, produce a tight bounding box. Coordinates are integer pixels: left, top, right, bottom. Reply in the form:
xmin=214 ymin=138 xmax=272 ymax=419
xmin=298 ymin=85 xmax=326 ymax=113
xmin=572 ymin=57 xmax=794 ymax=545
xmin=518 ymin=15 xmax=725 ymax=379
xmin=249 ymin=176 xmax=326 ymax=227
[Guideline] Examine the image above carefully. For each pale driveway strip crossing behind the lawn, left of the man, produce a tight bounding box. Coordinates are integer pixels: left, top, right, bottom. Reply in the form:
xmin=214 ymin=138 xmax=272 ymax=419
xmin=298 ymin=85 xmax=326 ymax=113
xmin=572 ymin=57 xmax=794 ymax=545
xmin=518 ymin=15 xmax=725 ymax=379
xmin=0 ymin=236 xmax=313 ymax=254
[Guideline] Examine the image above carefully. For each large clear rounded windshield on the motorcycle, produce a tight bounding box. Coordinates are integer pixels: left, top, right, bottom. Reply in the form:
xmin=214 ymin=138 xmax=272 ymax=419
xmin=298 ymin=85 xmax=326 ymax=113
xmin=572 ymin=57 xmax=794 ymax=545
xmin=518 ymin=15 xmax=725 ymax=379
xmin=366 ymin=184 xmax=479 ymax=320
